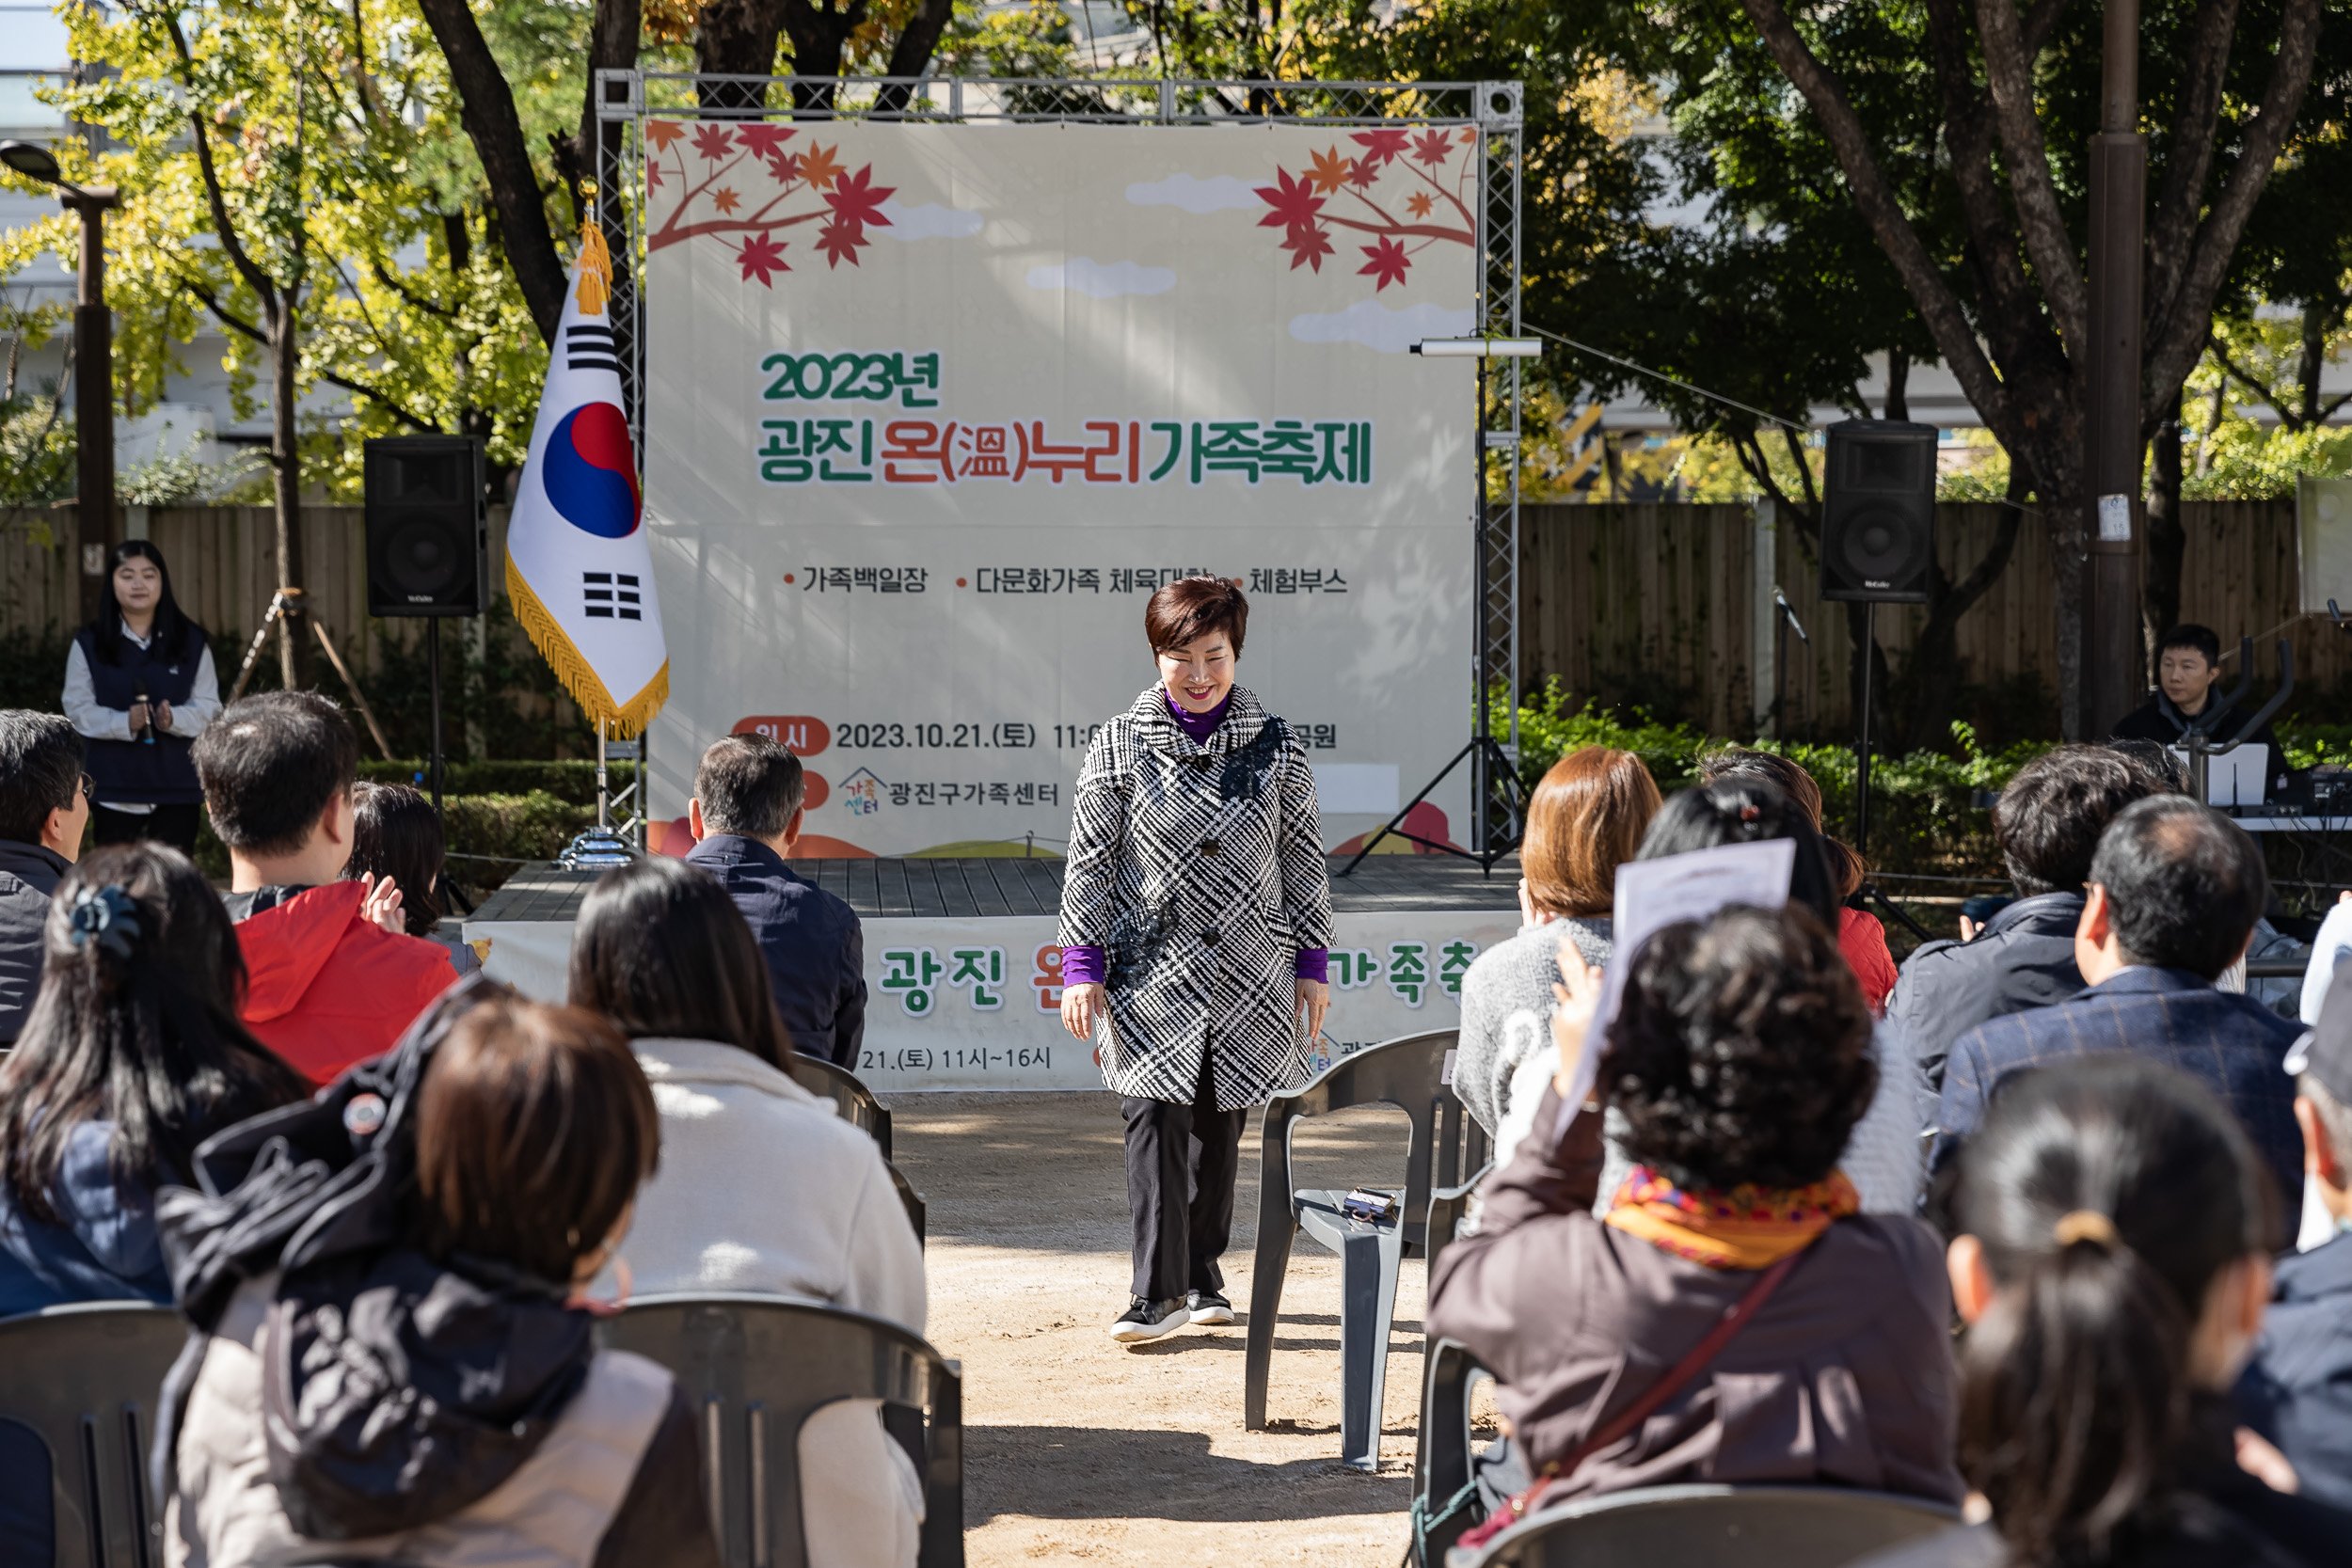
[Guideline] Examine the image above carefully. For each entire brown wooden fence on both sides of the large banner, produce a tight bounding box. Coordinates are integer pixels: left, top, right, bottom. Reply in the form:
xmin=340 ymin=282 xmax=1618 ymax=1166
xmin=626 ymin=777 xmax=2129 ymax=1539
xmin=0 ymin=500 xmax=2352 ymax=738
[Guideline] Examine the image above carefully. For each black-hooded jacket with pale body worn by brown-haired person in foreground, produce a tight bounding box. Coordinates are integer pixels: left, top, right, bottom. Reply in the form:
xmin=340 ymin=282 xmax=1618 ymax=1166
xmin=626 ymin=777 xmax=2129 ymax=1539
xmin=153 ymin=975 xmax=718 ymax=1568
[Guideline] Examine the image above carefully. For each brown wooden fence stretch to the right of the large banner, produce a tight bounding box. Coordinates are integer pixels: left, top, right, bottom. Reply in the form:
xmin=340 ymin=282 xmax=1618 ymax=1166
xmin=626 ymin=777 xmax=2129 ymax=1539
xmin=1519 ymin=500 xmax=2324 ymax=736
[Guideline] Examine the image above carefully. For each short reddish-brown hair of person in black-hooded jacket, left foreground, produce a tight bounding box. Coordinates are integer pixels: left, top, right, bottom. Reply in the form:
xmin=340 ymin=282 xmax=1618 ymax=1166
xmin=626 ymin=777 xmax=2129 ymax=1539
xmin=414 ymin=997 xmax=661 ymax=1286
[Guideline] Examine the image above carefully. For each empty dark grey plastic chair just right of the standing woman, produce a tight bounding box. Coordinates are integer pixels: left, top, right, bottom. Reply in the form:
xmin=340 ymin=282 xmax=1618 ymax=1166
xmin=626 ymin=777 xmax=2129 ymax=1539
xmin=1242 ymin=1030 xmax=1486 ymax=1472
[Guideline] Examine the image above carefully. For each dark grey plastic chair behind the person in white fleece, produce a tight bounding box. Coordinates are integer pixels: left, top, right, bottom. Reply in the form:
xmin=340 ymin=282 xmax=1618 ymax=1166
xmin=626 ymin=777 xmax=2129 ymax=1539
xmin=597 ymin=1295 xmax=964 ymax=1568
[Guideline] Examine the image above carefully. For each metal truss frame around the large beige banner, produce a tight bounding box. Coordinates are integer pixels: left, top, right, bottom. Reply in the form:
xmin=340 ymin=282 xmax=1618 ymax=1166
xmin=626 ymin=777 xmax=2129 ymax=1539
xmin=596 ymin=71 xmax=1524 ymax=865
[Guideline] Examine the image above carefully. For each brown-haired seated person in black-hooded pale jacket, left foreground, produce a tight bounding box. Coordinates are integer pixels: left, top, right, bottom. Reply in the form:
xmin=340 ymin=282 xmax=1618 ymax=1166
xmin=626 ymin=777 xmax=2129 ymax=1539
xmin=160 ymin=980 xmax=720 ymax=1568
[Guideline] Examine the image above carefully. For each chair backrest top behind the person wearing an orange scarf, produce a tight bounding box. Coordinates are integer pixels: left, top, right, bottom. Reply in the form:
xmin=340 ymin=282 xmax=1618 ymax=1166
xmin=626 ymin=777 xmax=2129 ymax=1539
xmin=1480 ymin=1486 xmax=1960 ymax=1568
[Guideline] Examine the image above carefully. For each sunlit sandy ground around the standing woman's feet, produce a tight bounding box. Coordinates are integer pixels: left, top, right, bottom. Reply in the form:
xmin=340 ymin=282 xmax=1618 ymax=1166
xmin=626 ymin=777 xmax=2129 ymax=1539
xmin=889 ymin=1093 xmax=1468 ymax=1568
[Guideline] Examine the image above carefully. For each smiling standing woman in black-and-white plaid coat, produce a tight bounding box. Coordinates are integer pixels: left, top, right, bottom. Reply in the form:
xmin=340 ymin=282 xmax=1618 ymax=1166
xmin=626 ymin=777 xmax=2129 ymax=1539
xmin=1061 ymin=576 xmax=1331 ymax=1342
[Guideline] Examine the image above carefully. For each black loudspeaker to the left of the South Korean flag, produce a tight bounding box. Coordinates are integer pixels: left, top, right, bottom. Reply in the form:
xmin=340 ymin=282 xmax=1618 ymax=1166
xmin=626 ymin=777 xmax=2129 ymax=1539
xmin=362 ymin=435 xmax=489 ymax=616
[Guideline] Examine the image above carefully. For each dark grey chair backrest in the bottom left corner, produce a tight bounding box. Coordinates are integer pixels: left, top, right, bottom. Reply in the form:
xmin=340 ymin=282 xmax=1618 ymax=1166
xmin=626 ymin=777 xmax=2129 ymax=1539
xmin=0 ymin=1303 xmax=188 ymax=1568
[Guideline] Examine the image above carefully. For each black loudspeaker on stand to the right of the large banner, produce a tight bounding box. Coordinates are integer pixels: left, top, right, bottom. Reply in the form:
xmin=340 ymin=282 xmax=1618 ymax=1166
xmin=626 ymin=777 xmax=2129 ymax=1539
xmin=1820 ymin=419 xmax=1936 ymax=604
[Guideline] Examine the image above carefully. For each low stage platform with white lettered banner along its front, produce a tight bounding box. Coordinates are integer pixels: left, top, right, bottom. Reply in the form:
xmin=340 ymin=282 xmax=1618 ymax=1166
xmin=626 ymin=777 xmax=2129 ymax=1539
xmin=466 ymin=856 xmax=1519 ymax=1091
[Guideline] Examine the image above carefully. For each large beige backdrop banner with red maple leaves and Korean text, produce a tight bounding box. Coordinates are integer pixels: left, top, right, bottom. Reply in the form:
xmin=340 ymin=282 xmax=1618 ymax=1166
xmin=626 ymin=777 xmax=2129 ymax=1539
xmin=644 ymin=119 xmax=1480 ymax=856
